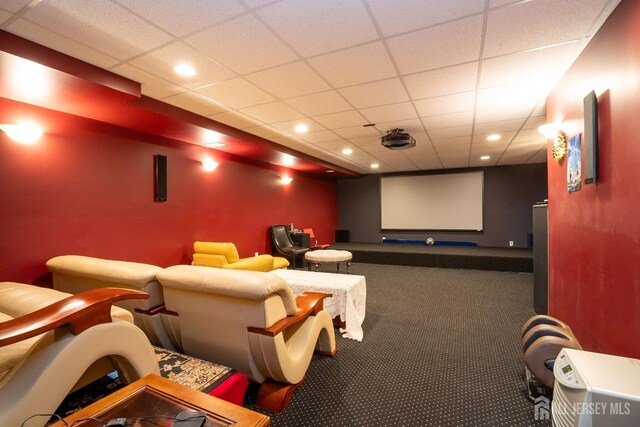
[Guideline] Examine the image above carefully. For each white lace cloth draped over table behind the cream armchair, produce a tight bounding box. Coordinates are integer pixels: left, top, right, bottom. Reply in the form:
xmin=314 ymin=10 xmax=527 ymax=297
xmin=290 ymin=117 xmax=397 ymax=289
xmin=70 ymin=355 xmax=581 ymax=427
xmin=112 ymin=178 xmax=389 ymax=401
xmin=271 ymin=270 xmax=367 ymax=341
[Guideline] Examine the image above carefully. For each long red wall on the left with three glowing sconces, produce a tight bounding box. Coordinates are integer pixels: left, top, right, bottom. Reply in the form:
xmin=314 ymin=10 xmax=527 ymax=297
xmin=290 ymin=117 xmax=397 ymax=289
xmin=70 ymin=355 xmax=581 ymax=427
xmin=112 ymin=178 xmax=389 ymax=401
xmin=0 ymin=99 xmax=337 ymax=283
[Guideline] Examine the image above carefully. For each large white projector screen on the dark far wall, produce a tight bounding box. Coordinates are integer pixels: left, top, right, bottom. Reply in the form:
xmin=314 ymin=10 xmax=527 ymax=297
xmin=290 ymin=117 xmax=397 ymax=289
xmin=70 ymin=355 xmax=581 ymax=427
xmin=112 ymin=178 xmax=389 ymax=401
xmin=380 ymin=171 xmax=484 ymax=231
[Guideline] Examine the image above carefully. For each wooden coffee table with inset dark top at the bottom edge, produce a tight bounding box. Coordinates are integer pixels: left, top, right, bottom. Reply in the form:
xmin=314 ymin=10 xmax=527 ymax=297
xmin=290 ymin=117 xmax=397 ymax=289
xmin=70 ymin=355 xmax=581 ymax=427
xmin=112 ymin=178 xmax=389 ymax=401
xmin=50 ymin=374 xmax=271 ymax=427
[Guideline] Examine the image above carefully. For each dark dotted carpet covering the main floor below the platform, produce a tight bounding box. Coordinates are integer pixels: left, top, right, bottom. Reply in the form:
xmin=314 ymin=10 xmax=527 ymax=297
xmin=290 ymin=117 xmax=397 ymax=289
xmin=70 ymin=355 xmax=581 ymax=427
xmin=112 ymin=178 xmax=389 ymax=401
xmin=245 ymin=263 xmax=550 ymax=426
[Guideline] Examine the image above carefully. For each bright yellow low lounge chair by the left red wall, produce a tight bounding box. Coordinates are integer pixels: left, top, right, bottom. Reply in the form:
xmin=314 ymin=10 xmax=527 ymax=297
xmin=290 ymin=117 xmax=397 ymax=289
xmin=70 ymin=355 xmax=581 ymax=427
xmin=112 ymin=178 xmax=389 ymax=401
xmin=191 ymin=241 xmax=289 ymax=271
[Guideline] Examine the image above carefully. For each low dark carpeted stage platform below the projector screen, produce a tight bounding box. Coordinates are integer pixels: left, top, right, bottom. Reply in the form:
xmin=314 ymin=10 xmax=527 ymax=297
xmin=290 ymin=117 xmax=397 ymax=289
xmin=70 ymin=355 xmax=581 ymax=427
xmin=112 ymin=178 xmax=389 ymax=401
xmin=331 ymin=243 xmax=533 ymax=273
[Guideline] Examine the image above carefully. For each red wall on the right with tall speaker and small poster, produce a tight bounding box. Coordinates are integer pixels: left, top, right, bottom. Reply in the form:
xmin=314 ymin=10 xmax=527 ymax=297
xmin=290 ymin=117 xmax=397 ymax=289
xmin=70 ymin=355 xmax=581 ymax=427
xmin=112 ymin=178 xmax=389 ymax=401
xmin=547 ymin=0 xmax=640 ymax=358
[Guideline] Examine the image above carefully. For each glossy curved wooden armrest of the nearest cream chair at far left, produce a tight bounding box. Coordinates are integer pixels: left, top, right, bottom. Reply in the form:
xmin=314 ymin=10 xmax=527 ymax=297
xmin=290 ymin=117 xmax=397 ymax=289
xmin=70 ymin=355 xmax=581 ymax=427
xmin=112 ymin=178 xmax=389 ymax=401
xmin=0 ymin=288 xmax=149 ymax=347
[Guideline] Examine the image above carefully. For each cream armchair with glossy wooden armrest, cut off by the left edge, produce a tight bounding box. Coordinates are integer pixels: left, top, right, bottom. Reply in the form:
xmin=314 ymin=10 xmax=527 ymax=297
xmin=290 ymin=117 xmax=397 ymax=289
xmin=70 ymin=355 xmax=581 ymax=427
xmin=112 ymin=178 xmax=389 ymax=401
xmin=0 ymin=282 xmax=159 ymax=426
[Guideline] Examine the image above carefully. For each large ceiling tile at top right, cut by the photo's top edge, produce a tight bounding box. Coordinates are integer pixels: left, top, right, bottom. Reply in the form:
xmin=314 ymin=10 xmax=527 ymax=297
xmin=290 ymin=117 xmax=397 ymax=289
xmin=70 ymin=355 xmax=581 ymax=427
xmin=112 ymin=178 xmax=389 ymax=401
xmin=484 ymin=0 xmax=608 ymax=57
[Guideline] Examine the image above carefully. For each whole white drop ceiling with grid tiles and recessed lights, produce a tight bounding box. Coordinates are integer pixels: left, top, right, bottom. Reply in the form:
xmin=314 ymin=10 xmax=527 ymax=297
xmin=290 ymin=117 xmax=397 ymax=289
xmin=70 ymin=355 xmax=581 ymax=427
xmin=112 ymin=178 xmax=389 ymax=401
xmin=0 ymin=0 xmax=619 ymax=174
